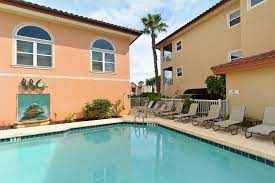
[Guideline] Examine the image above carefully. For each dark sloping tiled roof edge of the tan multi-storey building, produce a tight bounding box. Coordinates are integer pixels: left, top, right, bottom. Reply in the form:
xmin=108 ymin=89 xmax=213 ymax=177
xmin=157 ymin=0 xmax=232 ymax=48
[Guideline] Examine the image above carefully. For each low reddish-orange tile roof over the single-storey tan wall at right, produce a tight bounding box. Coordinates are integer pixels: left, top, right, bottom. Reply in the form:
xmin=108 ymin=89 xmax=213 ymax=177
xmin=211 ymin=50 xmax=275 ymax=75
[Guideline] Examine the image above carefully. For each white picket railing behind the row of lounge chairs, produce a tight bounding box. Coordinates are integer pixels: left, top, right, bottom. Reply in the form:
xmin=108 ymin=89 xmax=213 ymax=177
xmin=161 ymin=98 xmax=229 ymax=118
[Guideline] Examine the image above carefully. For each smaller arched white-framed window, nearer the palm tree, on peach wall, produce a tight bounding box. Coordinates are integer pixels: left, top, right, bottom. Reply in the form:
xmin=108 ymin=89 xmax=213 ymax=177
xmin=91 ymin=39 xmax=115 ymax=73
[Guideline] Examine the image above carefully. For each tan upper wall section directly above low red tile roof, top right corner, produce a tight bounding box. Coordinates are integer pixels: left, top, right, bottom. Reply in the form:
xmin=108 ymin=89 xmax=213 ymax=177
xmin=241 ymin=0 xmax=275 ymax=57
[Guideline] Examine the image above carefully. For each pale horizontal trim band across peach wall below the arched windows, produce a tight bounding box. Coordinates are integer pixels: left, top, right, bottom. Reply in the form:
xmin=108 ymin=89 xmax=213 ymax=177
xmin=0 ymin=72 xmax=130 ymax=82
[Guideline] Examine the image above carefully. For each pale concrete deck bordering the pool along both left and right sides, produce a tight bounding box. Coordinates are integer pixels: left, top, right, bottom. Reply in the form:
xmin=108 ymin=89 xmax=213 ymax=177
xmin=0 ymin=115 xmax=275 ymax=162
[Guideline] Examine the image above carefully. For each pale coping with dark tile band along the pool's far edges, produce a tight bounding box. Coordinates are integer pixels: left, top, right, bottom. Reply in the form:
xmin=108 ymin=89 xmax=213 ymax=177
xmin=0 ymin=117 xmax=275 ymax=167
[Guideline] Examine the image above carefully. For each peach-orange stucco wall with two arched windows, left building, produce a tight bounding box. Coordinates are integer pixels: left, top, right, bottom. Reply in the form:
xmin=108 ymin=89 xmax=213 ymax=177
xmin=0 ymin=12 xmax=133 ymax=122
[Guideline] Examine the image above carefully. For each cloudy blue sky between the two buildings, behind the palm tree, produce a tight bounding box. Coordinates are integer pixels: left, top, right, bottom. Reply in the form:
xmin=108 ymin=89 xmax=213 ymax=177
xmin=28 ymin=0 xmax=220 ymax=83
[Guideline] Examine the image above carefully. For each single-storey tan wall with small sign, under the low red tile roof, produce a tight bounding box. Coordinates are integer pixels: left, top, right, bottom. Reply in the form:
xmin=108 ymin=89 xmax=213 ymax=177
xmin=226 ymin=67 xmax=275 ymax=119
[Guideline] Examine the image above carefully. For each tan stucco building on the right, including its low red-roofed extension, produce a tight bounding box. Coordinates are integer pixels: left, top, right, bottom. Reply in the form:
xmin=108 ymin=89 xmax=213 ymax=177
xmin=157 ymin=0 xmax=275 ymax=119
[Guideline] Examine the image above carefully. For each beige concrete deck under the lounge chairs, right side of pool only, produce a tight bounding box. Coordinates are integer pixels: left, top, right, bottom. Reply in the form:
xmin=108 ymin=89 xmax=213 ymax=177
xmin=124 ymin=116 xmax=275 ymax=162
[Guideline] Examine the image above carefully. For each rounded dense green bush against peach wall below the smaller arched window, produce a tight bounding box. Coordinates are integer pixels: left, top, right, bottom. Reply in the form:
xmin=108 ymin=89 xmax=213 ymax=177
xmin=83 ymin=99 xmax=112 ymax=119
